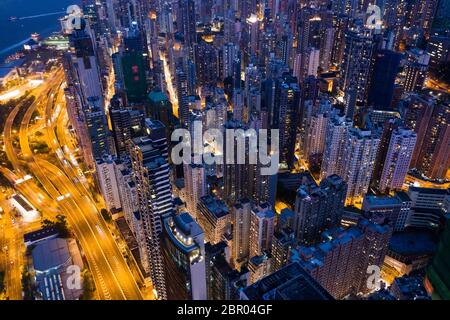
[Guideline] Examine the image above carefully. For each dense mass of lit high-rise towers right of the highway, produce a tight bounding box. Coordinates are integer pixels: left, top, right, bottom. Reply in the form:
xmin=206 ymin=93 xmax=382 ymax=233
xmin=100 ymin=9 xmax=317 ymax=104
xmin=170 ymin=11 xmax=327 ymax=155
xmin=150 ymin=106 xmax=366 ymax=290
xmin=63 ymin=0 xmax=450 ymax=300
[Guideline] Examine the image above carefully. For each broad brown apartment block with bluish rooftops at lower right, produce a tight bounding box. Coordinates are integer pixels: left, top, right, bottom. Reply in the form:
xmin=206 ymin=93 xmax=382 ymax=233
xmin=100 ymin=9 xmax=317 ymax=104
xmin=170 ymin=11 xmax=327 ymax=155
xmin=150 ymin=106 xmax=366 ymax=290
xmin=291 ymin=219 xmax=392 ymax=299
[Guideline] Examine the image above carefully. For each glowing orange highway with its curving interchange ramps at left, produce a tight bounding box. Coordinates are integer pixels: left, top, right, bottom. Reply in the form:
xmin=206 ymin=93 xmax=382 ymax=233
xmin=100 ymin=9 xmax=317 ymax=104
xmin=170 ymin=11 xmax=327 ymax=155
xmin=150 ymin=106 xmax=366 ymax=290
xmin=2 ymin=69 xmax=142 ymax=300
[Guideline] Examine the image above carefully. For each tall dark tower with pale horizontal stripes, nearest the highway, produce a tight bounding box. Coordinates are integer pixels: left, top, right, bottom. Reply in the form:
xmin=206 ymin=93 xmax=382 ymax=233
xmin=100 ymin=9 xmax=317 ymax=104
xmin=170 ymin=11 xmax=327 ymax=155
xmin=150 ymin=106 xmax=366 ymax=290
xmin=129 ymin=119 xmax=174 ymax=299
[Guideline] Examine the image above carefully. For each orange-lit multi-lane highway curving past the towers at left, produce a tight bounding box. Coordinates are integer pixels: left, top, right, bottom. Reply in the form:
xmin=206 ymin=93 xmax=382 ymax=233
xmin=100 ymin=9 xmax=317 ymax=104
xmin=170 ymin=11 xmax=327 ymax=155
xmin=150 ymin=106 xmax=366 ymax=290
xmin=5 ymin=69 xmax=142 ymax=300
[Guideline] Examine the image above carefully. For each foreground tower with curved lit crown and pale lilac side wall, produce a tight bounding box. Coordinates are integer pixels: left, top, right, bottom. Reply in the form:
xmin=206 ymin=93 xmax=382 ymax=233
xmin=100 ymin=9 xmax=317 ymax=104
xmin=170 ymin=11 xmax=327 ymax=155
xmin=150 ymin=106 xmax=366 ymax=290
xmin=161 ymin=212 xmax=207 ymax=300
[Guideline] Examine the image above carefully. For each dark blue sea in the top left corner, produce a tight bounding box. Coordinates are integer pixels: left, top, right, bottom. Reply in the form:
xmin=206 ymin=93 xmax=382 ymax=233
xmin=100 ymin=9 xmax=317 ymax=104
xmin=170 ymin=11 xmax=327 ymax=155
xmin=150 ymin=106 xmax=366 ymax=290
xmin=0 ymin=0 xmax=79 ymax=63
